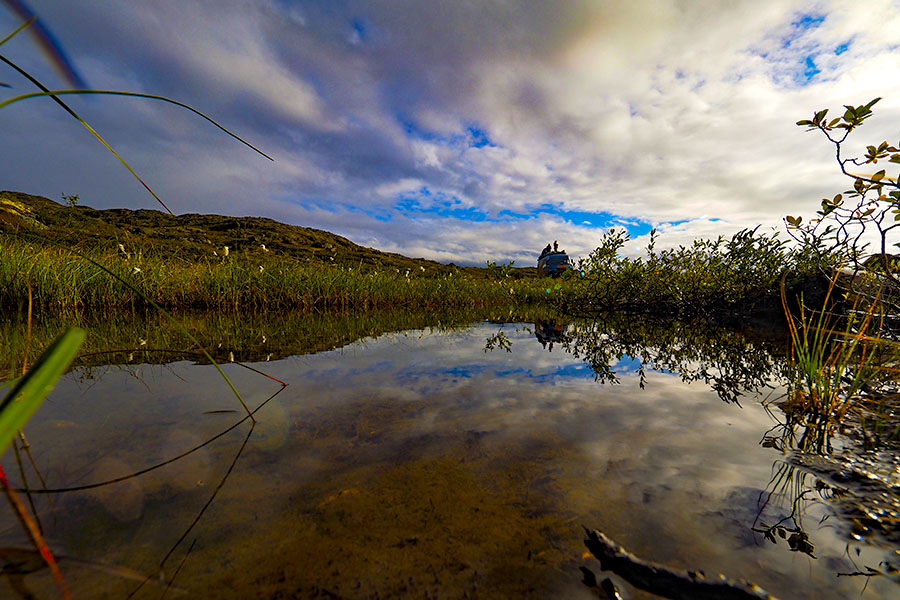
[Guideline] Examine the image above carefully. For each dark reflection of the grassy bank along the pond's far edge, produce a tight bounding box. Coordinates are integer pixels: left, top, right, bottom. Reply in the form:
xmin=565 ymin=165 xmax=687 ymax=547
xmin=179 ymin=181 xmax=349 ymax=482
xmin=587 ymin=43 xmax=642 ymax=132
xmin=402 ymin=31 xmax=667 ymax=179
xmin=0 ymin=306 xmax=564 ymax=376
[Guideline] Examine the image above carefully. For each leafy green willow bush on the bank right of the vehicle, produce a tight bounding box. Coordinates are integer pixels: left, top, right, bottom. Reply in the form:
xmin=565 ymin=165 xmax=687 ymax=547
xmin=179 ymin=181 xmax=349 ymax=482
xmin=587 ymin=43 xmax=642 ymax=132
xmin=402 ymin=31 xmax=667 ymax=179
xmin=563 ymin=227 xmax=837 ymax=316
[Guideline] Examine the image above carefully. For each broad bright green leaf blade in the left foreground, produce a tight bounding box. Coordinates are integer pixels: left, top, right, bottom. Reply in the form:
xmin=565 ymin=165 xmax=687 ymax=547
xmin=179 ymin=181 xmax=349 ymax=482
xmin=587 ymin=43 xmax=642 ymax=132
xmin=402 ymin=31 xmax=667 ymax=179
xmin=0 ymin=327 xmax=85 ymax=454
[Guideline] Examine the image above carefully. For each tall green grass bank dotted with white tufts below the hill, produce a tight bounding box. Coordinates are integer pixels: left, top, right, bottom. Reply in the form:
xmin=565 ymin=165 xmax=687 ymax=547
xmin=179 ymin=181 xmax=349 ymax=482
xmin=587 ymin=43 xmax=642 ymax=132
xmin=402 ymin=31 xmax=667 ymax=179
xmin=0 ymin=236 xmax=547 ymax=312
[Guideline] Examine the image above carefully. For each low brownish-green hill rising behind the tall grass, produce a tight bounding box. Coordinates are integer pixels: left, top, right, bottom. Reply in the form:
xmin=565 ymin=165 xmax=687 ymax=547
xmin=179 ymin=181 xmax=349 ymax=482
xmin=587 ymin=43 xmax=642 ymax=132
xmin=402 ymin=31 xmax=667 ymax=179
xmin=0 ymin=191 xmax=535 ymax=276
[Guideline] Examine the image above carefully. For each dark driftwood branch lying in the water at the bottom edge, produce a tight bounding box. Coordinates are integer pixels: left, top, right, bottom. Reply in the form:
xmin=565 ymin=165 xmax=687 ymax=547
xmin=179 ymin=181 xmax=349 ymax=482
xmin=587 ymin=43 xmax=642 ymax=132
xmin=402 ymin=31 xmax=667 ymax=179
xmin=584 ymin=528 xmax=777 ymax=600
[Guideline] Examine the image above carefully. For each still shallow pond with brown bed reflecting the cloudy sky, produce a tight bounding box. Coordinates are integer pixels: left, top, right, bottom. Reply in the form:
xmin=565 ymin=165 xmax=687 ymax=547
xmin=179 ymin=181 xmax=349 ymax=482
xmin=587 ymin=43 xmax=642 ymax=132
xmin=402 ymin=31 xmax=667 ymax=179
xmin=0 ymin=314 xmax=900 ymax=599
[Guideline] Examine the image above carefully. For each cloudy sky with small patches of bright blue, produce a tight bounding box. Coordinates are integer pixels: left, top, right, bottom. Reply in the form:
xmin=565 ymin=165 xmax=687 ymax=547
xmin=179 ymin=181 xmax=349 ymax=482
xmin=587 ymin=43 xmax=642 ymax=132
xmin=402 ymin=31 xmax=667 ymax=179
xmin=0 ymin=0 xmax=900 ymax=266
